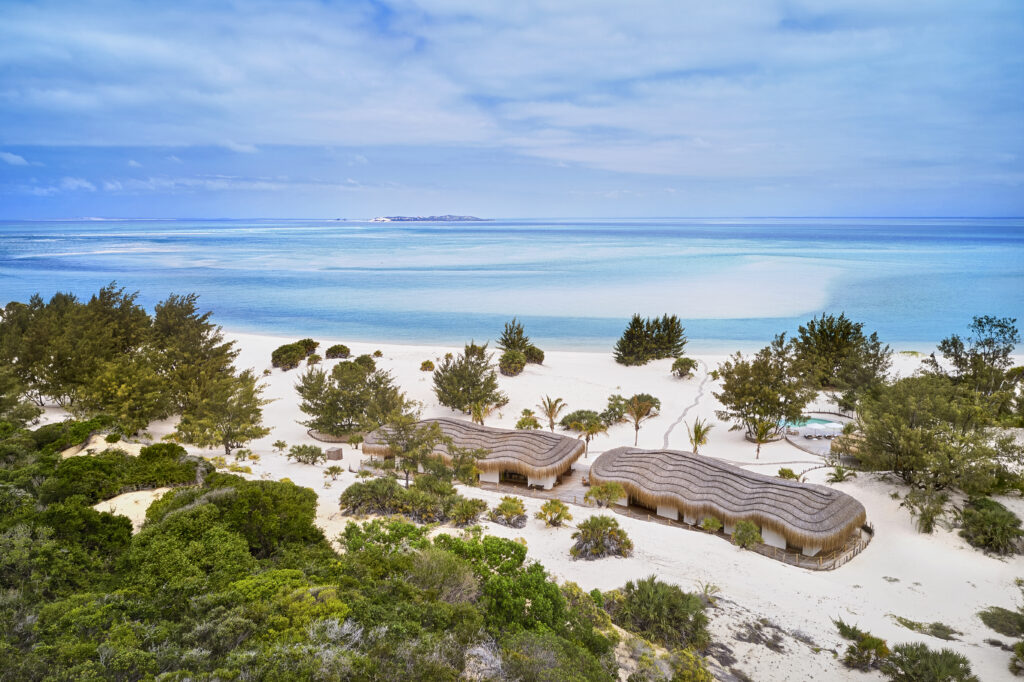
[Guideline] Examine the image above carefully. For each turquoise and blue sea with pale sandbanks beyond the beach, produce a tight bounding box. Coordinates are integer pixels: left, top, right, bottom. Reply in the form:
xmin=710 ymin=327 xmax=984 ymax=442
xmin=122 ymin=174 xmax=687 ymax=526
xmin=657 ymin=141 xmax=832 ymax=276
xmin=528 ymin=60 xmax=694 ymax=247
xmin=0 ymin=219 xmax=1024 ymax=349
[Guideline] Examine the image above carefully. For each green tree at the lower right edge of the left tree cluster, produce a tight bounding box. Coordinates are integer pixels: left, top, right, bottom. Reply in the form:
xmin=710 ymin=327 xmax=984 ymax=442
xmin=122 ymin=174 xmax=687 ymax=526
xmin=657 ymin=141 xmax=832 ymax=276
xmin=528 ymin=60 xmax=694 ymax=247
xmin=174 ymin=370 xmax=270 ymax=456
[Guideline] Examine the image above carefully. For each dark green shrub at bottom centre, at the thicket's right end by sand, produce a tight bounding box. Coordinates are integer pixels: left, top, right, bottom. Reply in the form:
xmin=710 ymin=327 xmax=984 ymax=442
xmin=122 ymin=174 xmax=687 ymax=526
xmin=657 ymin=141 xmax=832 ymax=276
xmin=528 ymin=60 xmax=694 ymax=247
xmin=611 ymin=576 xmax=711 ymax=651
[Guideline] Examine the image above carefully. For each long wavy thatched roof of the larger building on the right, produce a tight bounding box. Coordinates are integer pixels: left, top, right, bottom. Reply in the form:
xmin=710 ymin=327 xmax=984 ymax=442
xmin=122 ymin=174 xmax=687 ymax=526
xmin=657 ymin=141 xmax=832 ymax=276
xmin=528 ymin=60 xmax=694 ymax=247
xmin=590 ymin=447 xmax=866 ymax=551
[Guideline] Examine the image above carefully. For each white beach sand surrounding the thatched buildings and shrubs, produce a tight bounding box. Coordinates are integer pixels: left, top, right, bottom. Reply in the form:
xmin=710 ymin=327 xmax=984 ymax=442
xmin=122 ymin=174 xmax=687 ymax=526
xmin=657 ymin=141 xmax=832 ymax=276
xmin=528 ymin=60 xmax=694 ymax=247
xmin=74 ymin=334 xmax=1024 ymax=680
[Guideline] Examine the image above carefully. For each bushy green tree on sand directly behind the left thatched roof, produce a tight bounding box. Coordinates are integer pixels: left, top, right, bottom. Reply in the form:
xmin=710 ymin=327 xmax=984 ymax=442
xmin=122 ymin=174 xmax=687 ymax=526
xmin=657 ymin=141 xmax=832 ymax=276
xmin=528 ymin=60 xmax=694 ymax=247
xmin=433 ymin=343 xmax=508 ymax=411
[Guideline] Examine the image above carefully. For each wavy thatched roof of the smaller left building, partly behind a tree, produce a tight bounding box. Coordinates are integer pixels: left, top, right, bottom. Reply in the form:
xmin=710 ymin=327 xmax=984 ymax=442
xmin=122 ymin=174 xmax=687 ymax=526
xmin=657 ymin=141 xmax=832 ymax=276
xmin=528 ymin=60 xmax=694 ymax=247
xmin=362 ymin=419 xmax=584 ymax=477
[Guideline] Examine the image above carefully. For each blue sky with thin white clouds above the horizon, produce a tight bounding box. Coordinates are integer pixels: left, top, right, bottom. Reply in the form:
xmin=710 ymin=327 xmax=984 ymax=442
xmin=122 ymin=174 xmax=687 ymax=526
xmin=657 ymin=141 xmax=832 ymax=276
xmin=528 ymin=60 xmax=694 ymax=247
xmin=0 ymin=0 xmax=1024 ymax=219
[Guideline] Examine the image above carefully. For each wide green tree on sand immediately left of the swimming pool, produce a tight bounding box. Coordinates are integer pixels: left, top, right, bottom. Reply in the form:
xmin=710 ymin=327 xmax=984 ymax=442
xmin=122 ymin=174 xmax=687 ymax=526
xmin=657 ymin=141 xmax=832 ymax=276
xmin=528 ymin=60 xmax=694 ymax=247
xmin=715 ymin=334 xmax=816 ymax=438
